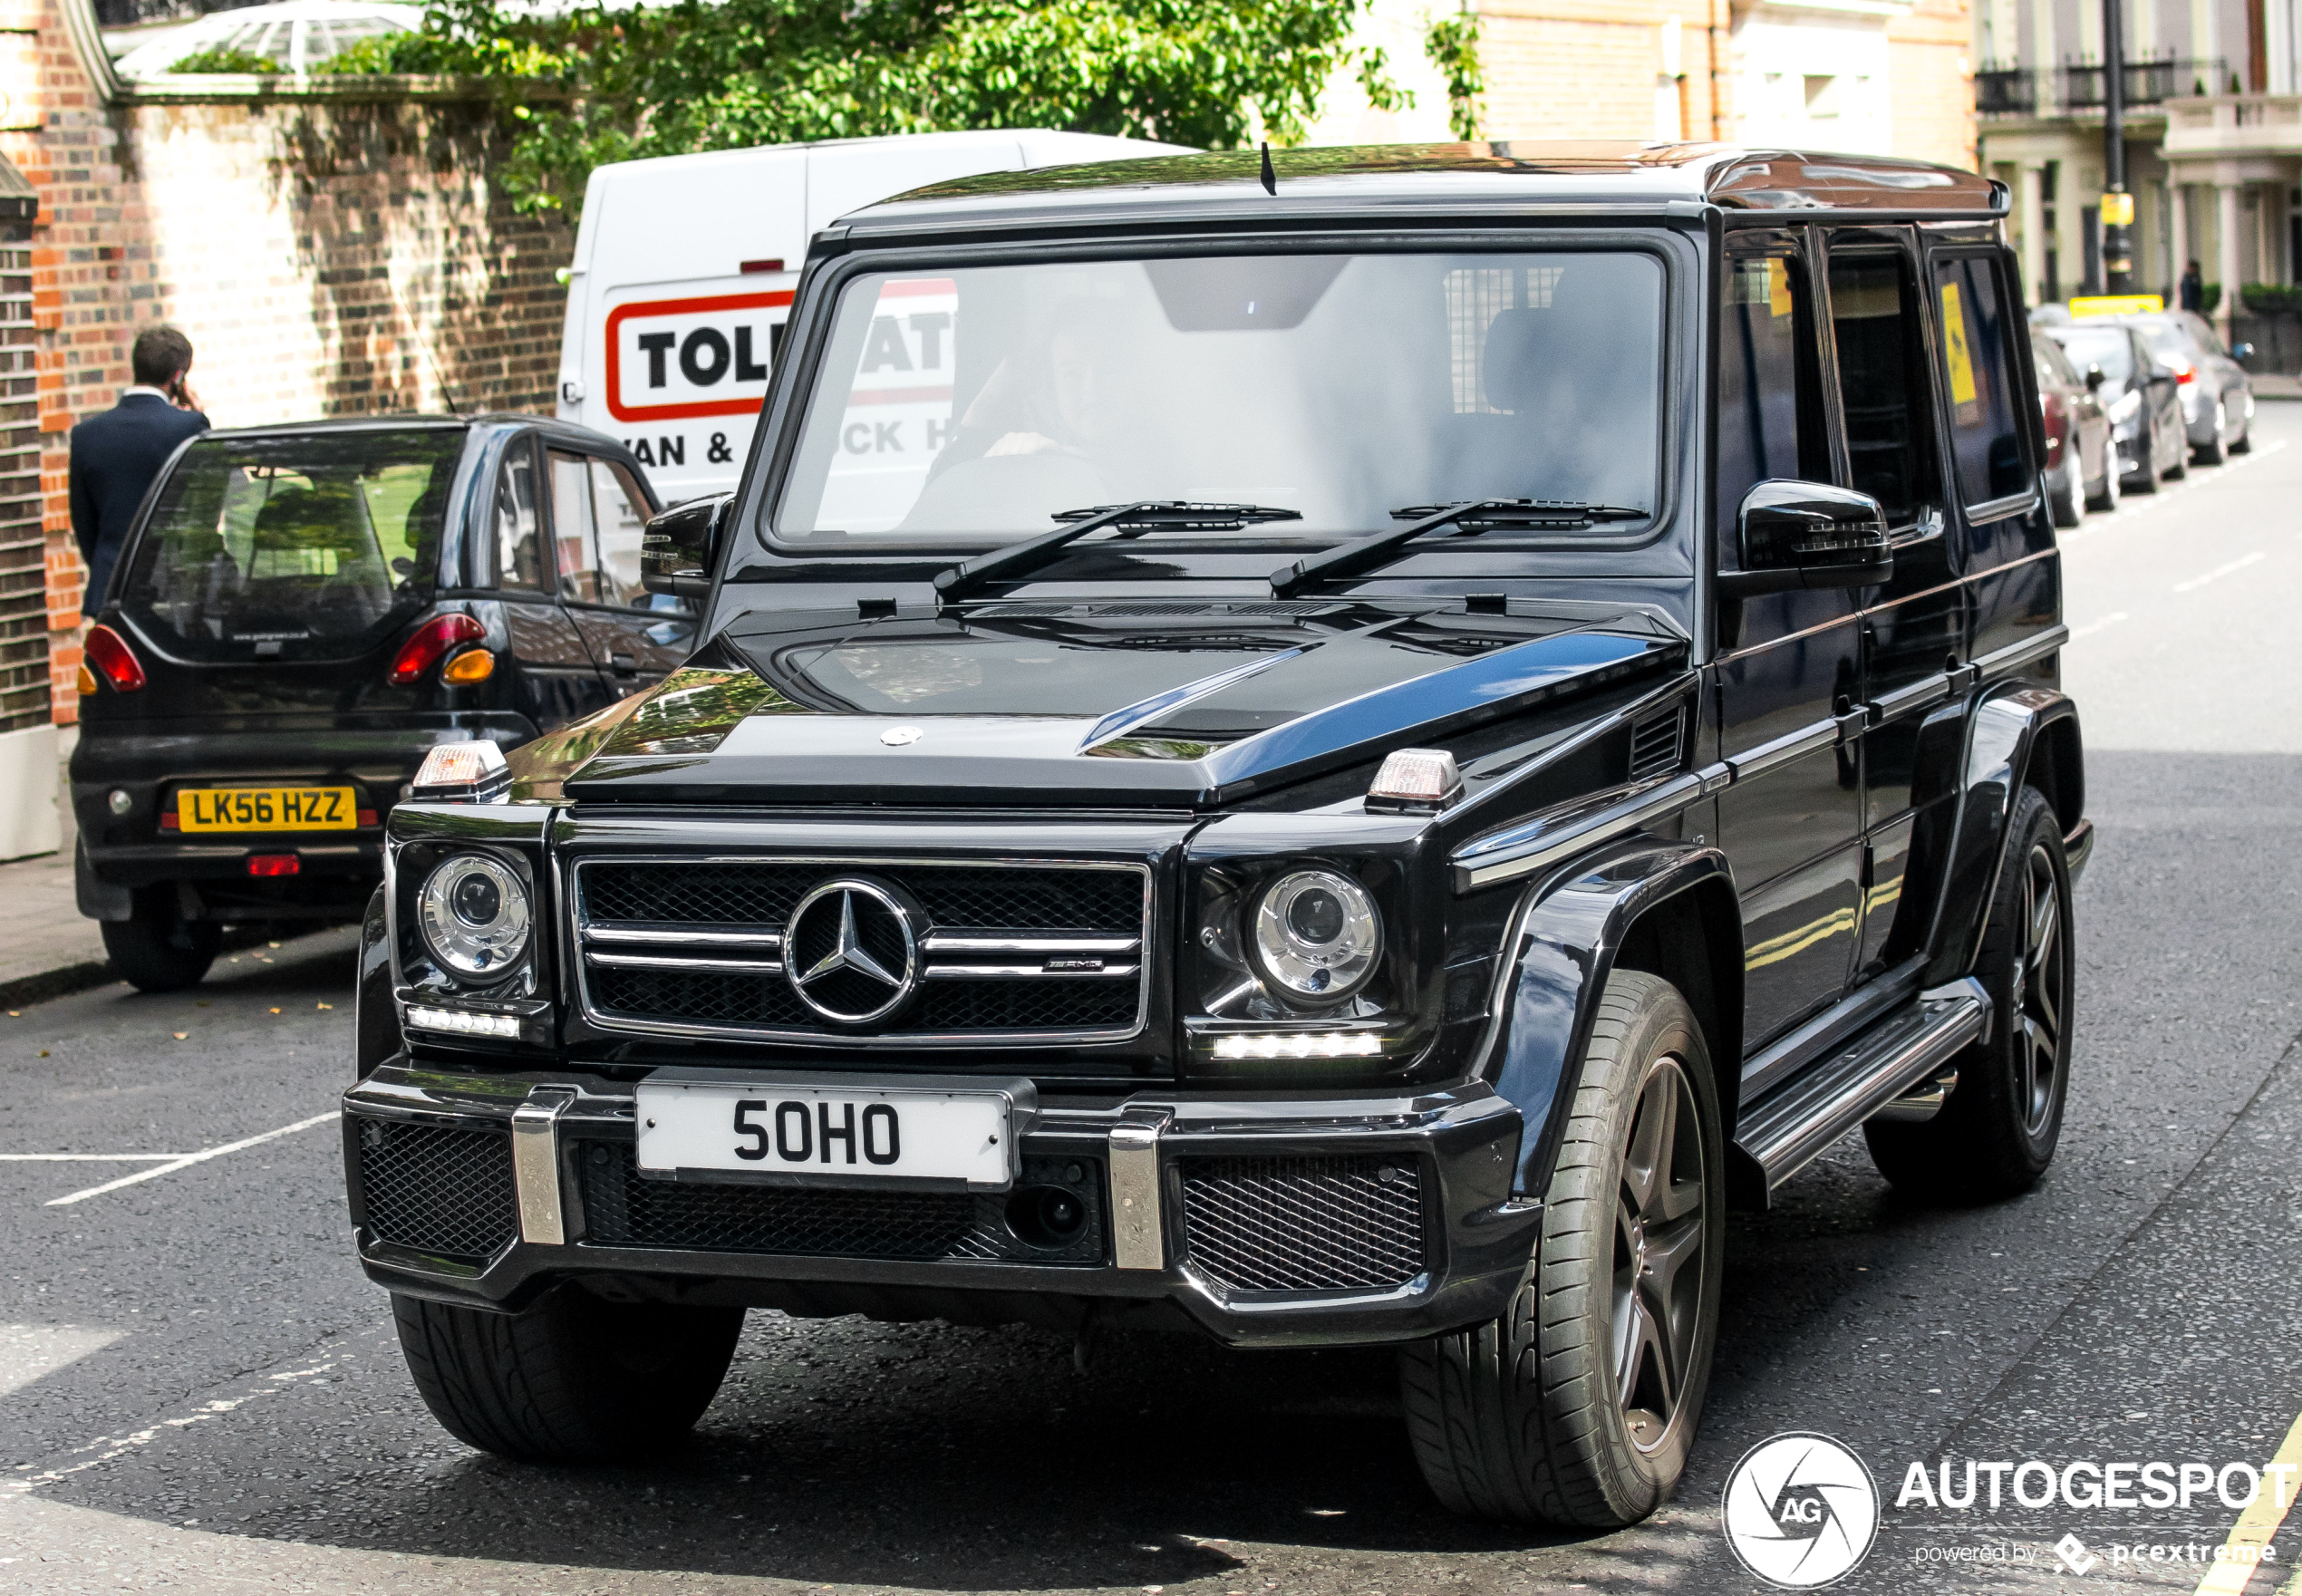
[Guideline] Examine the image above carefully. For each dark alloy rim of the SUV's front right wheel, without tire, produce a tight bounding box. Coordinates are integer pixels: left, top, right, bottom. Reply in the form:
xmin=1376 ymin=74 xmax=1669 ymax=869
xmin=1614 ymin=1055 xmax=1710 ymax=1451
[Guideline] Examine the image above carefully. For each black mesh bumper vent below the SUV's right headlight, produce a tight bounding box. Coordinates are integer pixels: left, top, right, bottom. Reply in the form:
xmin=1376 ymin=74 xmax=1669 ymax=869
xmin=1181 ymin=1156 xmax=1423 ymax=1292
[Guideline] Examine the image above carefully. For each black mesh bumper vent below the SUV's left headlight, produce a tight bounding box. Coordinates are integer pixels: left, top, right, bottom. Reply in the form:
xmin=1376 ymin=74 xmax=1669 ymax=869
xmin=359 ymin=1119 xmax=520 ymax=1264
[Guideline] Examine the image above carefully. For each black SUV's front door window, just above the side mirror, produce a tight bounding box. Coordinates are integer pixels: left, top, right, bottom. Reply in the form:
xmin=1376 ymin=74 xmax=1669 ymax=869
xmin=1717 ymin=256 xmax=1830 ymax=527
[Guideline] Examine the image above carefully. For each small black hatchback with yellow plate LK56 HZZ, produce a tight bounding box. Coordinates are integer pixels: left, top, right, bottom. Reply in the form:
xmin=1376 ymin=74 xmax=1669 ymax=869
xmin=72 ymin=414 xmax=695 ymax=991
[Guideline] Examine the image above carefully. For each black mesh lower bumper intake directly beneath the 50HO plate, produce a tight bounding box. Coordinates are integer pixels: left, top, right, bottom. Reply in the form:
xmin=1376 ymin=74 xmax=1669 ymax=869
xmin=580 ymin=1142 xmax=1107 ymax=1264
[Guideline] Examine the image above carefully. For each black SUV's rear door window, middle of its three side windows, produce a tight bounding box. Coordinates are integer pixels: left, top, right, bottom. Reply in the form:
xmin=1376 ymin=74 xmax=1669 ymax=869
xmin=1830 ymin=256 xmax=1936 ymax=527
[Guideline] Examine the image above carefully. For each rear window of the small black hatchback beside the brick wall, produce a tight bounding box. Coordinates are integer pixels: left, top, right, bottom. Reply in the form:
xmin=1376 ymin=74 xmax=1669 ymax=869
xmin=124 ymin=426 xmax=463 ymax=661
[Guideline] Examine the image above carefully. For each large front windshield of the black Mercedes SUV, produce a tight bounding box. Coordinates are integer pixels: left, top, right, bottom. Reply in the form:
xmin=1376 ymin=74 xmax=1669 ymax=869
xmin=776 ymin=251 xmax=1662 ymax=544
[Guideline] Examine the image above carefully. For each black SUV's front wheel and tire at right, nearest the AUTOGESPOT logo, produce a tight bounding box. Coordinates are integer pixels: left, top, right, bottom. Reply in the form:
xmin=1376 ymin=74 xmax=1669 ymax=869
xmin=1399 ymin=970 xmax=1726 ymax=1529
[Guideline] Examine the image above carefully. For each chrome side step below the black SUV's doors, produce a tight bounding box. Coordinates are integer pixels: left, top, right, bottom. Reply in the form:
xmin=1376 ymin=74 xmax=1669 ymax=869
xmin=1736 ymin=976 xmax=1991 ymax=1191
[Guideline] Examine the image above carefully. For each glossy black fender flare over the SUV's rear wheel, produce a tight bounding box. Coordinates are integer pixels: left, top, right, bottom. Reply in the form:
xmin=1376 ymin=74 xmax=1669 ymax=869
xmin=1924 ymin=682 xmax=2085 ymax=986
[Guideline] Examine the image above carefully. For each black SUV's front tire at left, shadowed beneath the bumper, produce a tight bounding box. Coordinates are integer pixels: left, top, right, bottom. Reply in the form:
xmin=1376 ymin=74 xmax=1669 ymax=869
xmin=392 ymin=1285 xmax=743 ymax=1463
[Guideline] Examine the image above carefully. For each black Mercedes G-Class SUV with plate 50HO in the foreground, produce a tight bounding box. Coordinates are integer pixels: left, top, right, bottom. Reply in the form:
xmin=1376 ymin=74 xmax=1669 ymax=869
xmin=343 ymin=143 xmax=2093 ymax=1524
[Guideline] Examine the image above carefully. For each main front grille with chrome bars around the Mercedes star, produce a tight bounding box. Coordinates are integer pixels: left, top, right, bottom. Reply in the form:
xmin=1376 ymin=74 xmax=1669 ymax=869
xmin=571 ymin=859 xmax=1151 ymax=1046
